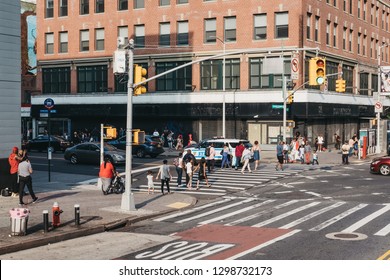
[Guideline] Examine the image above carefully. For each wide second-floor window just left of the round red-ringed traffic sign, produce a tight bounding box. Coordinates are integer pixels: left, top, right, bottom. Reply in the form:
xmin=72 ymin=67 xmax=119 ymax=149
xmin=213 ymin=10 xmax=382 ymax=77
xmin=249 ymin=58 xmax=291 ymax=89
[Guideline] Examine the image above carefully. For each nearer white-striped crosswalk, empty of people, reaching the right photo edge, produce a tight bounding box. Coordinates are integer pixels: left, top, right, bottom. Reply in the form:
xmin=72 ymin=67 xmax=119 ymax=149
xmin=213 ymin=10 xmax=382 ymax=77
xmin=154 ymin=196 xmax=390 ymax=236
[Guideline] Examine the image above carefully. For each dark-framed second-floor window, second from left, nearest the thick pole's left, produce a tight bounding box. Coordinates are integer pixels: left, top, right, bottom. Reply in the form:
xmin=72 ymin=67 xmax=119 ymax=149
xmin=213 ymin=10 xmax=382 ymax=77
xmin=77 ymin=65 xmax=108 ymax=93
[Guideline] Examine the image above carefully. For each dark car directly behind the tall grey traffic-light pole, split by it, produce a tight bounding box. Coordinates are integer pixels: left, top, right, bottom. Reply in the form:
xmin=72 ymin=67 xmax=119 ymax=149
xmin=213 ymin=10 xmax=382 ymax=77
xmin=107 ymin=135 xmax=165 ymax=158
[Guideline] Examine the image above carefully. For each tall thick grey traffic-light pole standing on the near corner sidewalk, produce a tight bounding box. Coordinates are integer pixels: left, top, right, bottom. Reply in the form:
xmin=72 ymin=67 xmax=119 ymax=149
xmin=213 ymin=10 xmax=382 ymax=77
xmin=121 ymin=39 xmax=136 ymax=211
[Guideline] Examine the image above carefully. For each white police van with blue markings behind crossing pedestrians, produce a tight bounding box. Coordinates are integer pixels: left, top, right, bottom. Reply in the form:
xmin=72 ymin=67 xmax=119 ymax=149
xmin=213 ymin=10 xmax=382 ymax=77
xmin=183 ymin=138 xmax=252 ymax=165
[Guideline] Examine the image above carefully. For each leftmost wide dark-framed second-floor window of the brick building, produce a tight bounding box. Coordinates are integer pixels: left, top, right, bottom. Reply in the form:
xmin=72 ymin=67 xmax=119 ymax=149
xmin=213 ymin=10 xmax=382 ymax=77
xmin=42 ymin=67 xmax=70 ymax=94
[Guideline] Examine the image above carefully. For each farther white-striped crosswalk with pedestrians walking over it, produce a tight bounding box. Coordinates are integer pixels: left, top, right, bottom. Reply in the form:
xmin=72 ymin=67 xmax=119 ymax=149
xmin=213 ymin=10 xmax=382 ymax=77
xmin=132 ymin=169 xmax=300 ymax=196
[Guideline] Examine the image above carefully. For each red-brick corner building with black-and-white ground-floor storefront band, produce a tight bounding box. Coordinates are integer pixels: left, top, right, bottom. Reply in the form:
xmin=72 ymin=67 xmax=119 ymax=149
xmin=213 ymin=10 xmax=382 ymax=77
xmin=31 ymin=0 xmax=390 ymax=148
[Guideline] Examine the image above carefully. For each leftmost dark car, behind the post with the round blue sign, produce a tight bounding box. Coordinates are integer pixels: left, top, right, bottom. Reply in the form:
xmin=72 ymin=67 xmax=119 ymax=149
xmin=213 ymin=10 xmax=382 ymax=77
xmin=24 ymin=135 xmax=71 ymax=152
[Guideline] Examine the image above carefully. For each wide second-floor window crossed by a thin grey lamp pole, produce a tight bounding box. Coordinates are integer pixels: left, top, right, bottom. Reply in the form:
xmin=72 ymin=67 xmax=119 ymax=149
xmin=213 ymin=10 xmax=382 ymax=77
xmin=200 ymin=59 xmax=240 ymax=90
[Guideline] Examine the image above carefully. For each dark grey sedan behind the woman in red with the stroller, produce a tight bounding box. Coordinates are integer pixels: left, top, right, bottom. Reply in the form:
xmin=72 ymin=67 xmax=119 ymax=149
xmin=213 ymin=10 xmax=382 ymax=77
xmin=64 ymin=142 xmax=126 ymax=165
